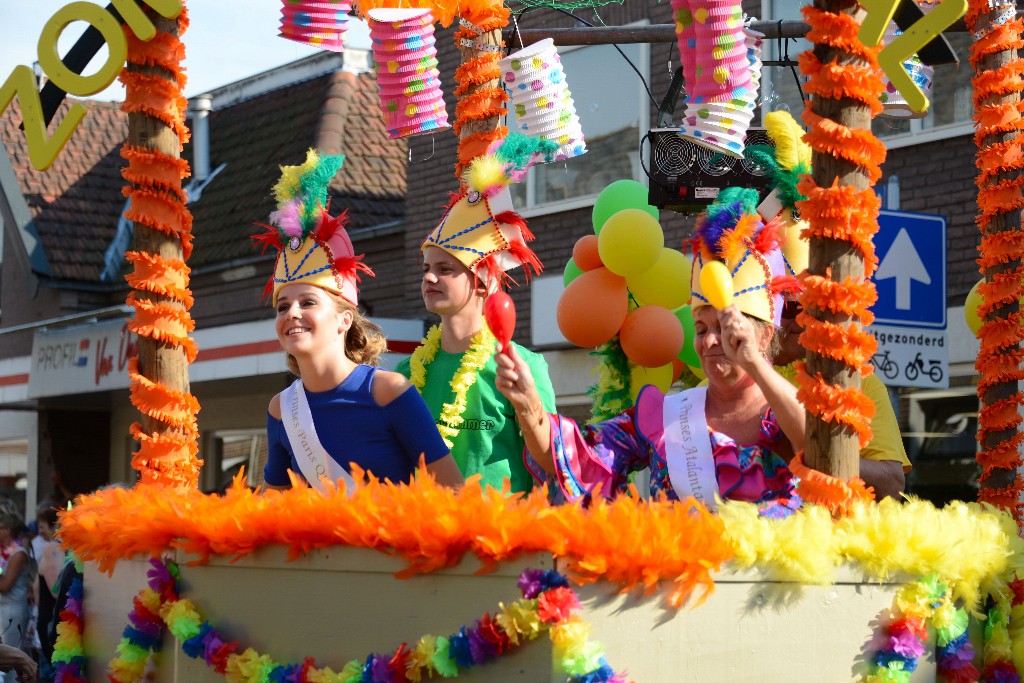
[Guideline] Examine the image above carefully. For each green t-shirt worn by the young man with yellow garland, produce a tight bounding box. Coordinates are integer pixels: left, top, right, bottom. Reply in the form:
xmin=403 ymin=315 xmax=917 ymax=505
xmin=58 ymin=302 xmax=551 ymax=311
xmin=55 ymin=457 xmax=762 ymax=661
xmin=395 ymin=344 xmax=555 ymax=492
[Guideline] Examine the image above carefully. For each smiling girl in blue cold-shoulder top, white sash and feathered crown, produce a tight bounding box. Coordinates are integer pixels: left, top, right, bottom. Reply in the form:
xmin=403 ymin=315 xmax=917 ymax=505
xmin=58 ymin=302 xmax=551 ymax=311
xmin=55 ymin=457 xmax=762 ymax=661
xmin=254 ymin=151 xmax=462 ymax=490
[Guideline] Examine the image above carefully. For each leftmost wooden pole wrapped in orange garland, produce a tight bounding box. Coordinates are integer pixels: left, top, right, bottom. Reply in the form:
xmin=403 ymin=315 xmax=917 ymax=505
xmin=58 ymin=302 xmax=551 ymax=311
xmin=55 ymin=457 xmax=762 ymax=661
xmin=121 ymin=3 xmax=202 ymax=489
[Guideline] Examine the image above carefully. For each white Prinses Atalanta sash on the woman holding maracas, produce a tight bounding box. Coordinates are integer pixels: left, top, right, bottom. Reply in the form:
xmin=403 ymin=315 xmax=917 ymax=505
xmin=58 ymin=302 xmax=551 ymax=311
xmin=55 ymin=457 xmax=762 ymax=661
xmin=662 ymin=387 xmax=718 ymax=512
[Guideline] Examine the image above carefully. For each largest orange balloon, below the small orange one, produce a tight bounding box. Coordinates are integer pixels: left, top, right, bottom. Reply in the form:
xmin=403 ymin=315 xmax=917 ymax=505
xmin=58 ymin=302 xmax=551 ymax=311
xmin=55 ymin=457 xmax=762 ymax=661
xmin=556 ymin=266 xmax=626 ymax=348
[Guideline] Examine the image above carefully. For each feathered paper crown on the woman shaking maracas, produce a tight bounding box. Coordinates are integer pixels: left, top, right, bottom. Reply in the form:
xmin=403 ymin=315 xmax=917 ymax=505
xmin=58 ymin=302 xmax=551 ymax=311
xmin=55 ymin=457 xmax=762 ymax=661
xmin=690 ymin=187 xmax=799 ymax=326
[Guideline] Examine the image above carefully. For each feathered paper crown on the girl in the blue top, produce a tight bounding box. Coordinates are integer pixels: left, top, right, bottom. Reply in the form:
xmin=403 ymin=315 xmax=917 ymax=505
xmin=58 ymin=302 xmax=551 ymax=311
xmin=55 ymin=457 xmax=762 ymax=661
xmin=253 ymin=150 xmax=374 ymax=306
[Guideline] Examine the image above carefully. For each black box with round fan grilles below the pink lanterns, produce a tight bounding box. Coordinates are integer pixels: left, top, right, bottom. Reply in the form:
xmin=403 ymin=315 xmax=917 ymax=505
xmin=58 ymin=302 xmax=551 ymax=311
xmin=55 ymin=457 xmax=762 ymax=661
xmin=647 ymin=128 xmax=774 ymax=213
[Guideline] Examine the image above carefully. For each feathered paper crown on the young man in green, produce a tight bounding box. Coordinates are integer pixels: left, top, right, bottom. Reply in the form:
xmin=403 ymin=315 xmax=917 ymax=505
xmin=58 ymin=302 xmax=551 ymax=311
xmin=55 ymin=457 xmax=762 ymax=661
xmin=421 ymin=132 xmax=558 ymax=285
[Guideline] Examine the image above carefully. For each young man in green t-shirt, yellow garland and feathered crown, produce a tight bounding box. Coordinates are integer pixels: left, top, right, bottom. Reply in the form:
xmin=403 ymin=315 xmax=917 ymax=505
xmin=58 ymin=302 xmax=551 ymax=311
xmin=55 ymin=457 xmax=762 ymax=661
xmin=396 ymin=133 xmax=557 ymax=493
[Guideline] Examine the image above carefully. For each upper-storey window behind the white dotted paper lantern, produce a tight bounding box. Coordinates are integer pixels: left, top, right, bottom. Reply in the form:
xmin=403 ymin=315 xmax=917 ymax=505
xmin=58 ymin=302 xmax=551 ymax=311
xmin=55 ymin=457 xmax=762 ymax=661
xmin=507 ymin=38 xmax=650 ymax=212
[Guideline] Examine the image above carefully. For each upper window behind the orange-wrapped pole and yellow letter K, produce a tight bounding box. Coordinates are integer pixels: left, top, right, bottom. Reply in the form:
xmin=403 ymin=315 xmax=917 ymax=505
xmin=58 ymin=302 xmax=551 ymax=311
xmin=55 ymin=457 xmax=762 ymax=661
xmin=760 ymin=0 xmax=974 ymax=147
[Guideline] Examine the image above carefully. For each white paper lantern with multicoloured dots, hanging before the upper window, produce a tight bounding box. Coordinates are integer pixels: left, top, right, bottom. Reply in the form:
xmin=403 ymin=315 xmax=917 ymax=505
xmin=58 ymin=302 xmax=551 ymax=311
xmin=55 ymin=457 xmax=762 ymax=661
xmin=498 ymin=38 xmax=587 ymax=161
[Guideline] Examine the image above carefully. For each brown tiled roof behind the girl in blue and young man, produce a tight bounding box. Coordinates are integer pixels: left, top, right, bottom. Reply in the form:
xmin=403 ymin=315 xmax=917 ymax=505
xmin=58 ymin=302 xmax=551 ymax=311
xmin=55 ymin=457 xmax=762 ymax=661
xmin=186 ymin=71 xmax=407 ymax=267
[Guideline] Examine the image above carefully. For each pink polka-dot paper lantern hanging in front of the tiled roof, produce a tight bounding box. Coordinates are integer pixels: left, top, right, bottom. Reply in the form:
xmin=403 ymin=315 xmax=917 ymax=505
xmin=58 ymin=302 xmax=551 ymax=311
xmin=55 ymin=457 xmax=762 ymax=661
xmin=367 ymin=8 xmax=449 ymax=140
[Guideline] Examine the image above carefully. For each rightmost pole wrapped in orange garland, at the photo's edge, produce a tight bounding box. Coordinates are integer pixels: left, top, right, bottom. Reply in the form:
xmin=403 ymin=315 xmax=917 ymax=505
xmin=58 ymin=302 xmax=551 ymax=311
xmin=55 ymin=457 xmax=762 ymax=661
xmin=966 ymin=0 xmax=1024 ymax=524
